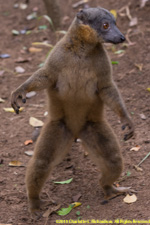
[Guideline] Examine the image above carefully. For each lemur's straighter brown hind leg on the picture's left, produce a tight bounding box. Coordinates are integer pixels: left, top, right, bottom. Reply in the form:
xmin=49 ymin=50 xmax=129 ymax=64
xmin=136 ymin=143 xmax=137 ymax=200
xmin=26 ymin=121 xmax=73 ymax=212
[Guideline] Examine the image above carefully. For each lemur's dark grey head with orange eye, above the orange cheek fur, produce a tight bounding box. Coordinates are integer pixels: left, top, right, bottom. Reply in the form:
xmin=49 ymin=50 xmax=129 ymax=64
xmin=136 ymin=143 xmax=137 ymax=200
xmin=77 ymin=8 xmax=125 ymax=44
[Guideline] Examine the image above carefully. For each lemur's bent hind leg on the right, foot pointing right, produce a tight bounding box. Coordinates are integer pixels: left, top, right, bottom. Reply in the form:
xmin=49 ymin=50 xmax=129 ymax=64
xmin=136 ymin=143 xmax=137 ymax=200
xmin=80 ymin=121 xmax=130 ymax=199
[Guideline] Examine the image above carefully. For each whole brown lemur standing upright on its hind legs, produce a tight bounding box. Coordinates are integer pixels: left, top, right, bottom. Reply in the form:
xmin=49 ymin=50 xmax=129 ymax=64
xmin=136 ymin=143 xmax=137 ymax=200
xmin=11 ymin=8 xmax=134 ymax=212
